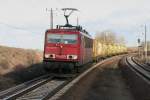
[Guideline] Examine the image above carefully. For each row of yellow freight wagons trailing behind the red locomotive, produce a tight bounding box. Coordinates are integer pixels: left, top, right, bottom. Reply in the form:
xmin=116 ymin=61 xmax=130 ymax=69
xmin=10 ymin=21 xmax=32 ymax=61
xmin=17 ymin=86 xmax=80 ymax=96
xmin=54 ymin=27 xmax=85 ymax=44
xmin=93 ymin=39 xmax=127 ymax=62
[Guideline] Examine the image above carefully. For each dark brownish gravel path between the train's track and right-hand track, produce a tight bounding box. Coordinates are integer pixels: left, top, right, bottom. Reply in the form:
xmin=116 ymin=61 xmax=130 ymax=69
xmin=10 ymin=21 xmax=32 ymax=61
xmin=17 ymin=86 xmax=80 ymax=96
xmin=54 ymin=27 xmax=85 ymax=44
xmin=60 ymin=58 xmax=134 ymax=100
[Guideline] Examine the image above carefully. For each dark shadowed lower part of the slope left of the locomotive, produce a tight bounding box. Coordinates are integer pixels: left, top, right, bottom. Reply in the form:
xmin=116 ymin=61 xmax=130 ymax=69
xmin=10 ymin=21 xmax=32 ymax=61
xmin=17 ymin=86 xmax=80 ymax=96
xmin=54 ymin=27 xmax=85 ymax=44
xmin=0 ymin=62 xmax=47 ymax=91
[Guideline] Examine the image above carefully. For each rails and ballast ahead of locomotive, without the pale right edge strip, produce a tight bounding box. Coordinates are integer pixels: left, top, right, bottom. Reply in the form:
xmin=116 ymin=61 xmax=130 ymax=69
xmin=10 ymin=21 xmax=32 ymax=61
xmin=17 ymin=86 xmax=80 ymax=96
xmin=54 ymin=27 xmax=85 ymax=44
xmin=0 ymin=74 xmax=71 ymax=100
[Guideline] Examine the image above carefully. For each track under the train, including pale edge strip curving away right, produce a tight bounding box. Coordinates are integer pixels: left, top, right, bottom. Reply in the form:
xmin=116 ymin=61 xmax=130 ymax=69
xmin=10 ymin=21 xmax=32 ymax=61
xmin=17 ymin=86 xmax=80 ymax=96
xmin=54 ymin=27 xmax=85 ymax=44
xmin=0 ymin=57 xmax=119 ymax=100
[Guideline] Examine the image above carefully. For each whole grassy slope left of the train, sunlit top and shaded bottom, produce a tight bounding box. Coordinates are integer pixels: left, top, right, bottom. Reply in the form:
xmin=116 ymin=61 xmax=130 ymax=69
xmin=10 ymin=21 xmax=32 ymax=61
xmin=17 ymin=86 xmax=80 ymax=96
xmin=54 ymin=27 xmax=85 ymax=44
xmin=0 ymin=46 xmax=46 ymax=90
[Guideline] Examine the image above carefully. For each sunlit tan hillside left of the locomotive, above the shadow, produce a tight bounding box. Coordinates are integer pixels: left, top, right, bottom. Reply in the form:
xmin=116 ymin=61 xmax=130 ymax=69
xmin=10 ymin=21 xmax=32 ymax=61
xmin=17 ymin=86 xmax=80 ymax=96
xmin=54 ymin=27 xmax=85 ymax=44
xmin=0 ymin=46 xmax=42 ymax=75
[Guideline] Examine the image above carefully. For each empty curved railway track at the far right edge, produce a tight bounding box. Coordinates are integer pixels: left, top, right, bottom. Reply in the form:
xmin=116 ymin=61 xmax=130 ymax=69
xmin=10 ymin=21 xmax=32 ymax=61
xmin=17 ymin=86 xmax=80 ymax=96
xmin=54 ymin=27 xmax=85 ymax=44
xmin=126 ymin=57 xmax=150 ymax=84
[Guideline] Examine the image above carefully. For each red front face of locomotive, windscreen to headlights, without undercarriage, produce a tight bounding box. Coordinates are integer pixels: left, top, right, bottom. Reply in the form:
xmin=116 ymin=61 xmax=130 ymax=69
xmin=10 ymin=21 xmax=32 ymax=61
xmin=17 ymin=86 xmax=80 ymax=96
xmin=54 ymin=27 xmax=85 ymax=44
xmin=44 ymin=30 xmax=80 ymax=62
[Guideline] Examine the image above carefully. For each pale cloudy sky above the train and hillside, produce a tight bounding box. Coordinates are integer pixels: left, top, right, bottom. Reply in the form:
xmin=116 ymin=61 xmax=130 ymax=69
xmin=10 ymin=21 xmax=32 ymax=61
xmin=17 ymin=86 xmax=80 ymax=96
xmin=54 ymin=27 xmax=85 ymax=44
xmin=0 ymin=0 xmax=150 ymax=50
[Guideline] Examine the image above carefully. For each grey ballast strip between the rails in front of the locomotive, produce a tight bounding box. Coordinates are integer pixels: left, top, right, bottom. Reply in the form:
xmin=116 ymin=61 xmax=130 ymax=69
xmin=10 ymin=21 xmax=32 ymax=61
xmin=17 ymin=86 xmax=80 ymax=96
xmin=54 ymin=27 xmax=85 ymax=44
xmin=17 ymin=79 xmax=68 ymax=100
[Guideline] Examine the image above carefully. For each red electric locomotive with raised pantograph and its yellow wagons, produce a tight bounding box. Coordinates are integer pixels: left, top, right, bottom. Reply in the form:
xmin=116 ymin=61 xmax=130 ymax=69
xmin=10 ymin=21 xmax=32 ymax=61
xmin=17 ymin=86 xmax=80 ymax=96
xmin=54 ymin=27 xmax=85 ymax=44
xmin=43 ymin=8 xmax=126 ymax=72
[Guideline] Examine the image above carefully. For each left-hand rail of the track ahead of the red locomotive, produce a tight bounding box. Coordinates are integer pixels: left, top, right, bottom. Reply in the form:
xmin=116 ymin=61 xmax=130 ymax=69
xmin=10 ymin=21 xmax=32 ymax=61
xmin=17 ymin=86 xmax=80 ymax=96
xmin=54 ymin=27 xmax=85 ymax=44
xmin=0 ymin=75 xmax=54 ymax=100
